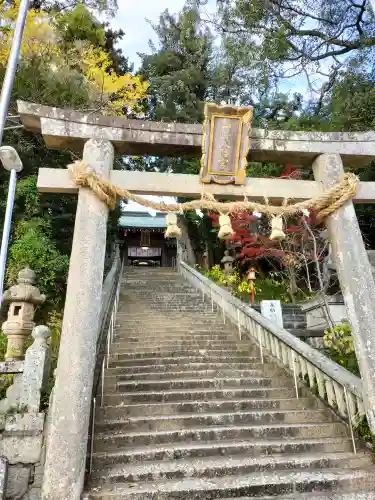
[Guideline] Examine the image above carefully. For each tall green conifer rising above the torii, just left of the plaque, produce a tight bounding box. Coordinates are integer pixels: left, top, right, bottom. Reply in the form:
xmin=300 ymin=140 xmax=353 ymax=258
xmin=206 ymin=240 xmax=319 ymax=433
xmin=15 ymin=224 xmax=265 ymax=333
xmin=141 ymin=3 xmax=213 ymax=122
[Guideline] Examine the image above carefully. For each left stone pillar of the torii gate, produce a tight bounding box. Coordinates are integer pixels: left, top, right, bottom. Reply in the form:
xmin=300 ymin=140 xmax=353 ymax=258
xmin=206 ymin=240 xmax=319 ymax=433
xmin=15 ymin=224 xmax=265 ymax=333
xmin=42 ymin=139 xmax=114 ymax=500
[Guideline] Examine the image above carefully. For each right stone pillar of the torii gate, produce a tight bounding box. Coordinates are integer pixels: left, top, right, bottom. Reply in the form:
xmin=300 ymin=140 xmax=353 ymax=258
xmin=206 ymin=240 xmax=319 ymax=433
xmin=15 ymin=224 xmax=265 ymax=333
xmin=313 ymin=154 xmax=375 ymax=430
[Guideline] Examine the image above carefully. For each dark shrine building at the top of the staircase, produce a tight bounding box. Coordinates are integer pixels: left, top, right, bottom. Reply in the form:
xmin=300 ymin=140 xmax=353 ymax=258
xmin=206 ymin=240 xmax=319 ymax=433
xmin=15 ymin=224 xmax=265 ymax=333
xmin=119 ymin=211 xmax=177 ymax=267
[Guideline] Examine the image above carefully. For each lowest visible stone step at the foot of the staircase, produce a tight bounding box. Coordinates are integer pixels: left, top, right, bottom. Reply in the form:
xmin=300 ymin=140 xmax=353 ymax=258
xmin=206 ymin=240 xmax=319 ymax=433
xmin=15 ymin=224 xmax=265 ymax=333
xmin=84 ymin=469 xmax=375 ymax=500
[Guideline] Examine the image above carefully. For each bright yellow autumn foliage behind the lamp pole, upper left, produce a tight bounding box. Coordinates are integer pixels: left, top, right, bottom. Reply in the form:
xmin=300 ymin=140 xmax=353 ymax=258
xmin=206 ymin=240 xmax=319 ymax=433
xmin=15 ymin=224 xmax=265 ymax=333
xmin=0 ymin=0 xmax=149 ymax=116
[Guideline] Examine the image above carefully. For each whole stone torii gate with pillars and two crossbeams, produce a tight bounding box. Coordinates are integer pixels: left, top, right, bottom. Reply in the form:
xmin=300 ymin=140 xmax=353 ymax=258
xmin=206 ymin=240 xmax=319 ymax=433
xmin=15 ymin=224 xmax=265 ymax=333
xmin=18 ymin=101 xmax=375 ymax=500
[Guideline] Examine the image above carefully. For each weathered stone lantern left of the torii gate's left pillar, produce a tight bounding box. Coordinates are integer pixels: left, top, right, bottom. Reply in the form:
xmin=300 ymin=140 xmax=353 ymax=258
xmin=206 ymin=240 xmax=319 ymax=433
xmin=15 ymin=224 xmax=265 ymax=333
xmin=2 ymin=268 xmax=46 ymax=361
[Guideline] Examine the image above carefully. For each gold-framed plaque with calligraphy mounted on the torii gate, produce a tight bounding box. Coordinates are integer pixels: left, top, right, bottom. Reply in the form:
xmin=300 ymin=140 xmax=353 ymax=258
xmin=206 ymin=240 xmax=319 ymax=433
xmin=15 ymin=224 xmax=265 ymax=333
xmin=201 ymin=104 xmax=253 ymax=185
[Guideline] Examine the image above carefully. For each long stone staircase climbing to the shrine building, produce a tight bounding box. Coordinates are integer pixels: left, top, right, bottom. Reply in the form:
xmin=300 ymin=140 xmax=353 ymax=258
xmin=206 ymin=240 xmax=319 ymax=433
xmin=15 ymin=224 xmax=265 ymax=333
xmin=84 ymin=268 xmax=375 ymax=500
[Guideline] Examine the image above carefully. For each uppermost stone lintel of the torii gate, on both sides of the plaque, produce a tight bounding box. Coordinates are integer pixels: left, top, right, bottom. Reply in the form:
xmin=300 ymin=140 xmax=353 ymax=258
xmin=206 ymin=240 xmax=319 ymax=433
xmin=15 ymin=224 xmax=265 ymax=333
xmin=17 ymin=101 xmax=375 ymax=167
